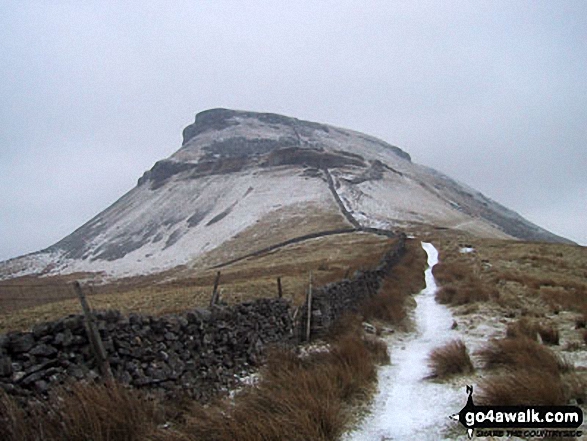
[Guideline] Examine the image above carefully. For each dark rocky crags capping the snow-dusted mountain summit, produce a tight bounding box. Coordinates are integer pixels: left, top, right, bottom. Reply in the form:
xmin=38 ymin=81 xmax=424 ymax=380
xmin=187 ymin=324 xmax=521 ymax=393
xmin=138 ymin=109 xmax=411 ymax=189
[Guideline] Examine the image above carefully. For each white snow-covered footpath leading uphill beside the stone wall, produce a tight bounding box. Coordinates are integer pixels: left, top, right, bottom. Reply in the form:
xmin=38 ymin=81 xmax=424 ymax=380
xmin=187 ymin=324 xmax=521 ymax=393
xmin=343 ymin=242 xmax=466 ymax=441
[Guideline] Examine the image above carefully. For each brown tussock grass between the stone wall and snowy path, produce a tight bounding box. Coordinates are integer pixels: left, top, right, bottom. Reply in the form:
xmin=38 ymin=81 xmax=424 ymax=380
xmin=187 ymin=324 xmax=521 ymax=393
xmin=0 ymin=329 xmax=388 ymax=441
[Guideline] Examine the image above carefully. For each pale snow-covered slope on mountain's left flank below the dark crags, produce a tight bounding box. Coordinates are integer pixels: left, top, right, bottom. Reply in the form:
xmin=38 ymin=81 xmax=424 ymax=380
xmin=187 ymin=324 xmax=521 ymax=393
xmin=13 ymin=168 xmax=332 ymax=277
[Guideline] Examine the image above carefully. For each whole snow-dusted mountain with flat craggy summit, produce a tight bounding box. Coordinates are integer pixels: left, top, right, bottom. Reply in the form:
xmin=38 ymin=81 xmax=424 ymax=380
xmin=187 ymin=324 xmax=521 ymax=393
xmin=0 ymin=109 xmax=564 ymax=278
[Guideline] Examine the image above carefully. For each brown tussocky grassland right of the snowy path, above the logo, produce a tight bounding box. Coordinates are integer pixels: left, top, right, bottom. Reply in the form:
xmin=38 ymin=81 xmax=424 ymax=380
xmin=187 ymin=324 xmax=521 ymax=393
xmin=434 ymin=236 xmax=587 ymax=405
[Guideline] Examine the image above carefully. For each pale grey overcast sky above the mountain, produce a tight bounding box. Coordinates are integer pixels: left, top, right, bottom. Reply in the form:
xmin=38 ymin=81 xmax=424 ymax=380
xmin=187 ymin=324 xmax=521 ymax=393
xmin=0 ymin=0 xmax=587 ymax=260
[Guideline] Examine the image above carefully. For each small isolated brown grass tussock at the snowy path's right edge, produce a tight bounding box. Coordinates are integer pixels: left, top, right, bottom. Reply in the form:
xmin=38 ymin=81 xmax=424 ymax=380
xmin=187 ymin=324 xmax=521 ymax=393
xmin=428 ymin=339 xmax=474 ymax=379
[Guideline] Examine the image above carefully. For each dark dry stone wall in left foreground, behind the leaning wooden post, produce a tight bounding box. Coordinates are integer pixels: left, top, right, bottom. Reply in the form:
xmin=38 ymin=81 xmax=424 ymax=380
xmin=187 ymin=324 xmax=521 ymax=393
xmin=0 ymin=299 xmax=293 ymax=401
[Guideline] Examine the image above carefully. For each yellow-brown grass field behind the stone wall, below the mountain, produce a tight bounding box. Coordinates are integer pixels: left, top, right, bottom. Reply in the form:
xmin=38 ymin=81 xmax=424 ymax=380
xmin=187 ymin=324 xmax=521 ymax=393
xmin=0 ymin=233 xmax=393 ymax=333
